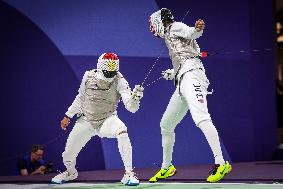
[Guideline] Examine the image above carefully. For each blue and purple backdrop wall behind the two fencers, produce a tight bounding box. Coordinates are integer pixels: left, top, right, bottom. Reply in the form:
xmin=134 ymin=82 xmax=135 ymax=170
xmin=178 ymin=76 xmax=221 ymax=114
xmin=0 ymin=0 xmax=276 ymax=175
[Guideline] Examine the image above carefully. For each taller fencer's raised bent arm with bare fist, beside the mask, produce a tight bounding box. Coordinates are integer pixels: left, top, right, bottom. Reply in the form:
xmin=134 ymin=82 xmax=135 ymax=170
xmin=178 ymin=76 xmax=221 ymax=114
xmin=170 ymin=20 xmax=205 ymax=39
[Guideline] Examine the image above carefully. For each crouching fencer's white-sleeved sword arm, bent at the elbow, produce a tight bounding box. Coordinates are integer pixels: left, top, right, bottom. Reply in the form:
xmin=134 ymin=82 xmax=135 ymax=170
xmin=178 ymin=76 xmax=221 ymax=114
xmin=117 ymin=77 xmax=143 ymax=113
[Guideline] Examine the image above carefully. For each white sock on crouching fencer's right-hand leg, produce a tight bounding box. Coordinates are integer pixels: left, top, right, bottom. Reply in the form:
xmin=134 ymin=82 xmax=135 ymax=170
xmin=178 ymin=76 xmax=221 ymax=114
xmin=117 ymin=133 xmax=133 ymax=172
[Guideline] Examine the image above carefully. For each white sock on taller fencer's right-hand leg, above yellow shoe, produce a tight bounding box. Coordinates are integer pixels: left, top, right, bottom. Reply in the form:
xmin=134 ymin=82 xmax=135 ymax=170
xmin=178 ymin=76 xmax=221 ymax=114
xmin=198 ymin=120 xmax=225 ymax=165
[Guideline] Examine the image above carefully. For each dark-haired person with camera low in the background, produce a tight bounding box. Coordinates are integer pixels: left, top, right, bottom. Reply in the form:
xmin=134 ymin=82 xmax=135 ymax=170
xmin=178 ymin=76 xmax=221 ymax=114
xmin=17 ymin=144 xmax=46 ymax=176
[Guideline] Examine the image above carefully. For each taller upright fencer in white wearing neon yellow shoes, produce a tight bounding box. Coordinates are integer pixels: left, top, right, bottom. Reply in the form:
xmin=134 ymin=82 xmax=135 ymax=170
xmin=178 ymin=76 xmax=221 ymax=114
xmin=149 ymin=8 xmax=231 ymax=182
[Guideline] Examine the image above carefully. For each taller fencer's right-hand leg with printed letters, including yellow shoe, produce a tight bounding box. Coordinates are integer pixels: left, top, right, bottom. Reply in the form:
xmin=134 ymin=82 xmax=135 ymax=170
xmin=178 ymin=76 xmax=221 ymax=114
xmin=181 ymin=70 xmax=231 ymax=182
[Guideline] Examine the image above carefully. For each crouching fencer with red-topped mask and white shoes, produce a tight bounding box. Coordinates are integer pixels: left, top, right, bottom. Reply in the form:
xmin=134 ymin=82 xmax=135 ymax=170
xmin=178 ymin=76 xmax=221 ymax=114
xmin=51 ymin=53 xmax=143 ymax=185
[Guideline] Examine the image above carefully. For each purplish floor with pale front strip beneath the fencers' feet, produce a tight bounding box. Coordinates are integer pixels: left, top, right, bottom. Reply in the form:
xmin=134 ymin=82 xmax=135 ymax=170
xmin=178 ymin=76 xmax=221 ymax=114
xmin=0 ymin=161 xmax=283 ymax=189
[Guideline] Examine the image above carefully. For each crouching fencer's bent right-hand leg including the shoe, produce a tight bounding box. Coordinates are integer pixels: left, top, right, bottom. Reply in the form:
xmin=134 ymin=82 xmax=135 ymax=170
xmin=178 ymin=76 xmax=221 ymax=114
xmin=99 ymin=115 xmax=139 ymax=185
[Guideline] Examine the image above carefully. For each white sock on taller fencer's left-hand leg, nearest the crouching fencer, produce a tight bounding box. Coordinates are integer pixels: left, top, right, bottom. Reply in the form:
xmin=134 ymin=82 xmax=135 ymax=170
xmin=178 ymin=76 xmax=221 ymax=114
xmin=161 ymin=132 xmax=175 ymax=169
